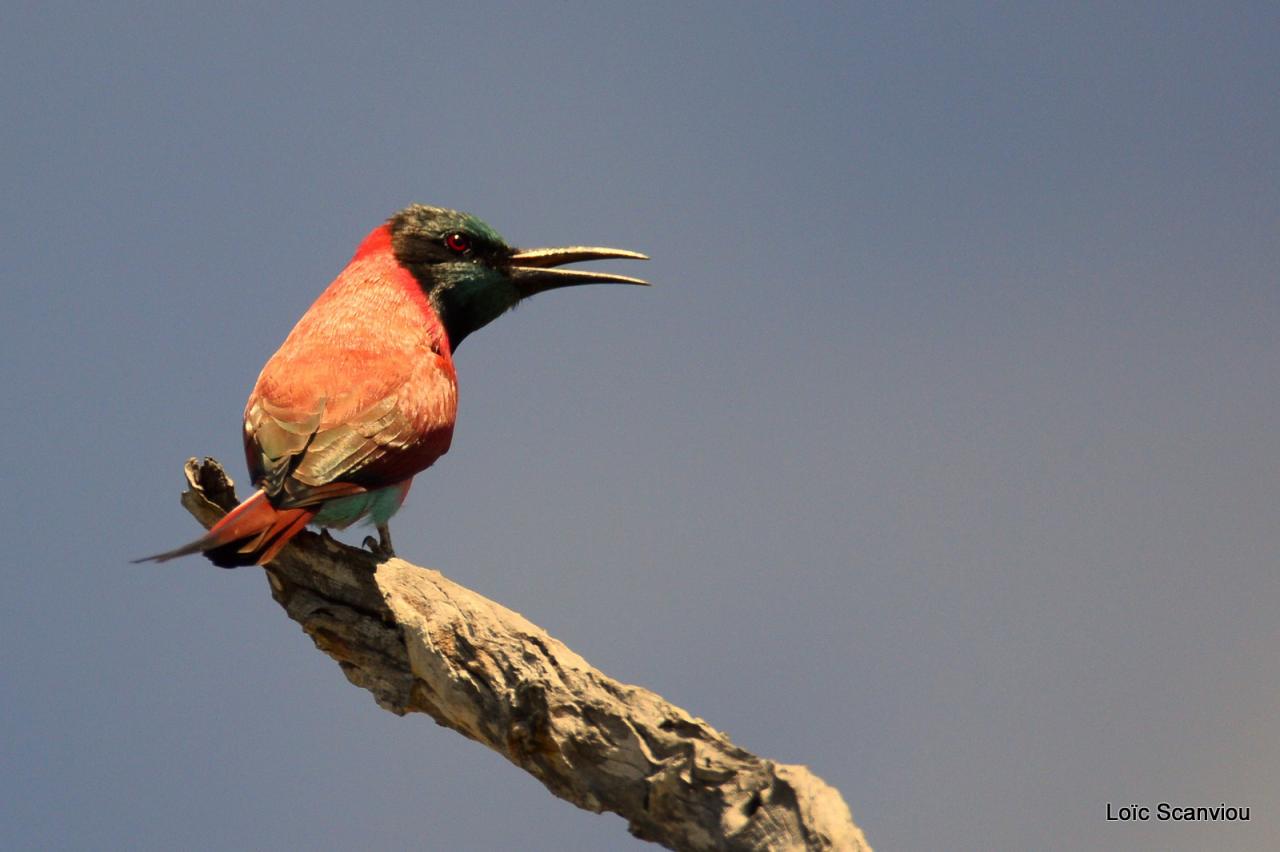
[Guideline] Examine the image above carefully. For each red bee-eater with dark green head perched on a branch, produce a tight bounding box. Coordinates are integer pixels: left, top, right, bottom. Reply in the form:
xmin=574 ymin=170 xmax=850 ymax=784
xmin=134 ymin=203 xmax=648 ymax=568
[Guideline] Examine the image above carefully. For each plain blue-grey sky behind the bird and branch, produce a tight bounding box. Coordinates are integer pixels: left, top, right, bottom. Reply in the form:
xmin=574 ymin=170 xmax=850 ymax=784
xmin=0 ymin=3 xmax=1280 ymax=851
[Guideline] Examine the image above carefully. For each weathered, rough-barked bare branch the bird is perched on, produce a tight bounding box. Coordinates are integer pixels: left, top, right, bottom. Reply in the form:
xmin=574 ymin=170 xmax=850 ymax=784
xmin=172 ymin=459 xmax=870 ymax=852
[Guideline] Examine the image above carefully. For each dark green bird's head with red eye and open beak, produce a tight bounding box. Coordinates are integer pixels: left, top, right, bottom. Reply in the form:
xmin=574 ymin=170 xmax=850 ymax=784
xmin=388 ymin=205 xmax=648 ymax=349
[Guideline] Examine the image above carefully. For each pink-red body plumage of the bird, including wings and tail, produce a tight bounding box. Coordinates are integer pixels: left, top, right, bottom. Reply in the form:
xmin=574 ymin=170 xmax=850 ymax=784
xmin=144 ymin=225 xmax=457 ymax=567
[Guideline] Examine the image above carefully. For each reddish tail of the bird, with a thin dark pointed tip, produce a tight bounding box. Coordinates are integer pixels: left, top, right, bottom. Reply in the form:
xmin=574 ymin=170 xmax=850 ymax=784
xmin=133 ymin=490 xmax=317 ymax=568
